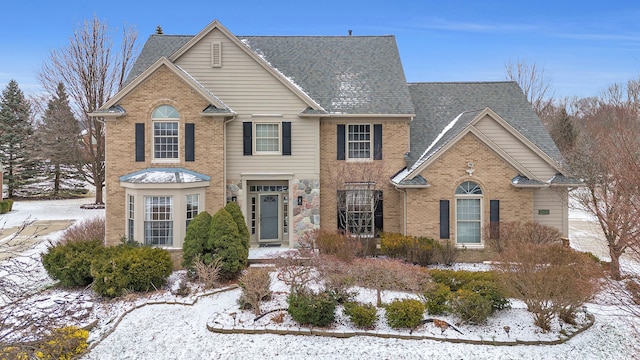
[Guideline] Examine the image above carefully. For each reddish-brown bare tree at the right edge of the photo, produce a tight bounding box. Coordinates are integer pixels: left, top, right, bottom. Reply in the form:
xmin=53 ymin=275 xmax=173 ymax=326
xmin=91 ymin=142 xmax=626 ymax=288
xmin=567 ymin=98 xmax=640 ymax=280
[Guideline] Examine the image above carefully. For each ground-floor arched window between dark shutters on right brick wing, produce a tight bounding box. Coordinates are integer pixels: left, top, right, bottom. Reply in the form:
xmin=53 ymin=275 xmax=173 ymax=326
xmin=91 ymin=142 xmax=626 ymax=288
xmin=456 ymin=181 xmax=482 ymax=245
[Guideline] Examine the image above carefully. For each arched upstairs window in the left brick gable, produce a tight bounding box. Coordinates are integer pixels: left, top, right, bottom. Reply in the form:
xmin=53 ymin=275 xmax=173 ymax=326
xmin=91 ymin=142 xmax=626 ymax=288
xmin=151 ymin=105 xmax=180 ymax=160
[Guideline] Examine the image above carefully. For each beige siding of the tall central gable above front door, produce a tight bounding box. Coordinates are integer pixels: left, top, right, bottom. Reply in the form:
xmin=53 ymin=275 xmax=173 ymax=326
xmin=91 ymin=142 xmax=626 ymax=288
xmin=176 ymin=29 xmax=319 ymax=179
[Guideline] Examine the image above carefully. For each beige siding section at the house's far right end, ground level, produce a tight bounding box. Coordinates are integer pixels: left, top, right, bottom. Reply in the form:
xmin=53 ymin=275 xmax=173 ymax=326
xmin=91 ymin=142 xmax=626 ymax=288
xmin=533 ymin=188 xmax=569 ymax=236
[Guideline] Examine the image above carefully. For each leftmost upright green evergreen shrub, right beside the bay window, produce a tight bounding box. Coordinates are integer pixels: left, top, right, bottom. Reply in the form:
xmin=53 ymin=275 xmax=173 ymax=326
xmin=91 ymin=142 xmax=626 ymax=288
xmin=182 ymin=211 xmax=213 ymax=270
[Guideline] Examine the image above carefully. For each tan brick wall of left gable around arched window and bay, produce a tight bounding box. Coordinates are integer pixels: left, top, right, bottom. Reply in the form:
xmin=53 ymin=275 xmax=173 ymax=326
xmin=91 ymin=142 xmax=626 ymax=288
xmin=105 ymin=67 xmax=230 ymax=245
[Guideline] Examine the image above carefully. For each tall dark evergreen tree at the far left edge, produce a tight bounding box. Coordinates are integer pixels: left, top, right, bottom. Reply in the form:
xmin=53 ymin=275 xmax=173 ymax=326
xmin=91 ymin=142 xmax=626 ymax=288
xmin=0 ymin=80 xmax=37 ymax=198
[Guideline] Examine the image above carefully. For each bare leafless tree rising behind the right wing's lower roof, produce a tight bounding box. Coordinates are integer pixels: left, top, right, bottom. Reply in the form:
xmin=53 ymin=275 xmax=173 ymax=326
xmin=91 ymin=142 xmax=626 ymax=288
xmin=504 ymin=60 xmax=553 ymax=117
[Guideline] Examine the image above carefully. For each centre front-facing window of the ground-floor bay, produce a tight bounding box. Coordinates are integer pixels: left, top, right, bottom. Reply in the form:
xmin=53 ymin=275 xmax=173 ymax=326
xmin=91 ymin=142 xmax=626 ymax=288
xmin=144 ymin=196 xmax=173 ymax=246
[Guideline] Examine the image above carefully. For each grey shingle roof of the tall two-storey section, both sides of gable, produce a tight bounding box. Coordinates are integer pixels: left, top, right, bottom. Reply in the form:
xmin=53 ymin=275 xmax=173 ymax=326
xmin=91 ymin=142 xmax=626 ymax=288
xmin=127 ymin=34 xmax=414 ymax=115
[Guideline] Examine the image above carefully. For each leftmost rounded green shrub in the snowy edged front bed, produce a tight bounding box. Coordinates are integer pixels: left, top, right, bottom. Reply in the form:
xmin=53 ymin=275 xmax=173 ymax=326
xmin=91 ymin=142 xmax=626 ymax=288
xmin=287 ymin=289 xmax=336 ymax=326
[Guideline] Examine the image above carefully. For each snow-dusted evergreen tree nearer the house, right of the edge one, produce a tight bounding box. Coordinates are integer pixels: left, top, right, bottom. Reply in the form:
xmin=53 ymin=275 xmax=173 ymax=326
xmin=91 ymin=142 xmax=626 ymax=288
xmin=38 ymin=83 xmax=82 ymax=195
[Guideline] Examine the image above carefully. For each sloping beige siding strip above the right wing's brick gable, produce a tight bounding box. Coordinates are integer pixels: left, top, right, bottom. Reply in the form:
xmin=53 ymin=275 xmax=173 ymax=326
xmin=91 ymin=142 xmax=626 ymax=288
xmin=475 ymin=116 xmax=557 ymax=181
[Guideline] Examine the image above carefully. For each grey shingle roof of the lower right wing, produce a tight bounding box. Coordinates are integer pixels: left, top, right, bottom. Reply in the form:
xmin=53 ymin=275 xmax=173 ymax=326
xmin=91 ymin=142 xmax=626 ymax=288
xmin=407 ymin=81 xmax=560 ymax=167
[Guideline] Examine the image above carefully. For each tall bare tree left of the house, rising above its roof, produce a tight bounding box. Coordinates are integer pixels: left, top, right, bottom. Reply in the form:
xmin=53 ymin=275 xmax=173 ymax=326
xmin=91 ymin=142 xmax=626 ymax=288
xmin=38 ymin=15 xmax=138 ymax=204
